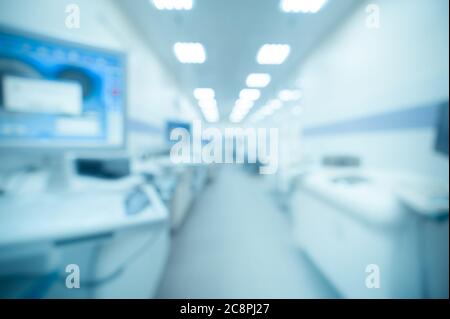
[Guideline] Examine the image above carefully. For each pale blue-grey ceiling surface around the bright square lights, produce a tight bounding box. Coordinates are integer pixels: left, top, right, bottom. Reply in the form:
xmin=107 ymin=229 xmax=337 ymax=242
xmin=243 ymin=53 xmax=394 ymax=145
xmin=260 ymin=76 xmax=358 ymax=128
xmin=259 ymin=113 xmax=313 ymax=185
xmin=117 ymin=0 xmax=361 ymax=121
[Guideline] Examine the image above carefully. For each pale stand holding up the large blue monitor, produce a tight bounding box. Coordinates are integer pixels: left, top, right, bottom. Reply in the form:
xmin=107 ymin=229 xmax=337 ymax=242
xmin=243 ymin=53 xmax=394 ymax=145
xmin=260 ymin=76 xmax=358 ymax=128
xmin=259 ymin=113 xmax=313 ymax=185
xmin=45 ymin=153 xmax=75 ymax=193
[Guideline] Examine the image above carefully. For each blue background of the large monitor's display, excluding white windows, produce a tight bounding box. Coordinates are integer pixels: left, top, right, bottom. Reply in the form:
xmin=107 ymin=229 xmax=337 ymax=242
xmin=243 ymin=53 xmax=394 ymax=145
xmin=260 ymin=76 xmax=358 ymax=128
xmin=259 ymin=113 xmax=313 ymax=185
xmin=0 ymin=29 xmax=125 ymax=143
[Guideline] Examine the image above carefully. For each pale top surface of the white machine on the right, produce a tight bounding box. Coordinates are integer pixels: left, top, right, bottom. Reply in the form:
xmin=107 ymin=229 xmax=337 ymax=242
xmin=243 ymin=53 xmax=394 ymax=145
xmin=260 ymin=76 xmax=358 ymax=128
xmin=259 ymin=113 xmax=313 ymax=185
xmin=299 ymin=169 xmax=448 ymax=226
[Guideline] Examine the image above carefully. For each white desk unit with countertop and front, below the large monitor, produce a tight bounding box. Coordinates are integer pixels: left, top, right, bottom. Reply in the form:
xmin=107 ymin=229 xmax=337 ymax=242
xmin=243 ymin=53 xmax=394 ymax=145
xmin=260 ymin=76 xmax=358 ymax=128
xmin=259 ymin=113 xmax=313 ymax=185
xmin=0 ymin=178 xmax=170 ymax=298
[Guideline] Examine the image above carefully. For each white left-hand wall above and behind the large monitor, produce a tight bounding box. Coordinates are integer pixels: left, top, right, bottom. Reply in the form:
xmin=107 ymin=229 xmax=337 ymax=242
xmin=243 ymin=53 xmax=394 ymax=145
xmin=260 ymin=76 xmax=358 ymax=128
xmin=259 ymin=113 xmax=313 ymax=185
xmin=0 ymin=0 xmax=200 ymax=156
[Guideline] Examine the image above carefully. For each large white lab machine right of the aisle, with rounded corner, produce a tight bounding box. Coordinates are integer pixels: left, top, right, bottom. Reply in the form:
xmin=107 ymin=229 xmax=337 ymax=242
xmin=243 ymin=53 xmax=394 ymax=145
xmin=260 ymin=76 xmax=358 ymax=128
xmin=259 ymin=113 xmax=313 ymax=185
xmin=292 ymin=169 xmax=448 ymax=298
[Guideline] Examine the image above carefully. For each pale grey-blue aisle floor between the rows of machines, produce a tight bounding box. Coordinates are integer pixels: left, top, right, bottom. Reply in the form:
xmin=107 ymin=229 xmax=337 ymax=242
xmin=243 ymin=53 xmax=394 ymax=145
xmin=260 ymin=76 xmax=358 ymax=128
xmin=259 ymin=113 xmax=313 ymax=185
xmin=158 ymin=166 xmax=339 ymax=298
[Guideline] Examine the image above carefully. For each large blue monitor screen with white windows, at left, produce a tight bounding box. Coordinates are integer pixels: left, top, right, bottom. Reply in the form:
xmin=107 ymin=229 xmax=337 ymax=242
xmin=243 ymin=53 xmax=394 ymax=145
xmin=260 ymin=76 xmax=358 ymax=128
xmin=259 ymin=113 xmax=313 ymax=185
xmin=0 ymin=29 xmax=125 ymax=148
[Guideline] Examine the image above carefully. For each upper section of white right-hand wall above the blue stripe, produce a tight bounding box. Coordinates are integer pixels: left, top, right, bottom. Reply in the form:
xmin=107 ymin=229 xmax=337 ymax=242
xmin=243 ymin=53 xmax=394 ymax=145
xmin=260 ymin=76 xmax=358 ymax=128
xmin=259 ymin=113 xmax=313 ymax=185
xmin=300 ymin=0 xmax=449 ymax=126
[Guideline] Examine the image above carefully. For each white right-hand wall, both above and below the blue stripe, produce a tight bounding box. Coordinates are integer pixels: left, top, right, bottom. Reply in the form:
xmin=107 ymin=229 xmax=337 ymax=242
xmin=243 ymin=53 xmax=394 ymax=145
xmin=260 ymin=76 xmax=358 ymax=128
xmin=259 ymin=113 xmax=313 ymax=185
xmin=267 ymin=0 xmax=449 ymax=178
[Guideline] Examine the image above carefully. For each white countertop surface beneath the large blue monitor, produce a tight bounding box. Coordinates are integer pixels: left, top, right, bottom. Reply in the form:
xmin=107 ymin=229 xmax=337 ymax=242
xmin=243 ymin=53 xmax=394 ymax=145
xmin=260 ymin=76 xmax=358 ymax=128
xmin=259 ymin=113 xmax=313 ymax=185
xmin=0 ymin=179 xmax=168 ymax=249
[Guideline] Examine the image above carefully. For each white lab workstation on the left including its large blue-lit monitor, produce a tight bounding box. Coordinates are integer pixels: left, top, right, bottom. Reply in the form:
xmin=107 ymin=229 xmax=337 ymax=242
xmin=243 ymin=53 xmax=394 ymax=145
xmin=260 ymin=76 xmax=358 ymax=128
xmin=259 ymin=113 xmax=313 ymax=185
xmin=0 ymin=28 xmax=169 ymax=298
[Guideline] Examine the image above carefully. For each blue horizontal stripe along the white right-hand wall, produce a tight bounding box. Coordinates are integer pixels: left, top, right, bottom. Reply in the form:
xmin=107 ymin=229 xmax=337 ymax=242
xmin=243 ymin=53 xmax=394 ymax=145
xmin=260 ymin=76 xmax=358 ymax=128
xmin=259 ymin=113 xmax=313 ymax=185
xmin=303 ymin=102 xmax=442 ymax=136
